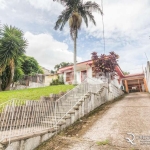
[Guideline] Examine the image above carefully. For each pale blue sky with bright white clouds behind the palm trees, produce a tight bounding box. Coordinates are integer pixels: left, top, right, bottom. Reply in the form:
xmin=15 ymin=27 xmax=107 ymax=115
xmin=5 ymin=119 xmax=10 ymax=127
xmin=0 ymin=0 xmax=150 ymax=73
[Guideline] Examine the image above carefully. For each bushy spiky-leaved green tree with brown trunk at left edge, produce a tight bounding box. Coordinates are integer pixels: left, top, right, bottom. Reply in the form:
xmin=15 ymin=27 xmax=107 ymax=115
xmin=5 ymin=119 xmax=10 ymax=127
xmin=0 ymin=25 xmax=27 ymax=90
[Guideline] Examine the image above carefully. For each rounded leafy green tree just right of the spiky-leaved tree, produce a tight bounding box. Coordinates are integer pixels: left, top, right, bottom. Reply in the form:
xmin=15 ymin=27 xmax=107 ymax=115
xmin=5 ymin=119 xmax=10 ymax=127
xmin=22 ymin=55 xmax=43 ymax=75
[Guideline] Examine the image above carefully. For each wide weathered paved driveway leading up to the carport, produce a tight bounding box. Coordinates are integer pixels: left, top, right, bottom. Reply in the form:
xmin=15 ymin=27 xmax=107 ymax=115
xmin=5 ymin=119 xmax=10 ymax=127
xmin=62 ymin=93 xmax=150 ymax=150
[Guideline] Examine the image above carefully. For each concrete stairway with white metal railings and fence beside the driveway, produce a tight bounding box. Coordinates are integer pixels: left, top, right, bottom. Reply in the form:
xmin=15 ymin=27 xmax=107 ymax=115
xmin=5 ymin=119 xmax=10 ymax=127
xmin=0 ymin=78 xmax=123 ymax=142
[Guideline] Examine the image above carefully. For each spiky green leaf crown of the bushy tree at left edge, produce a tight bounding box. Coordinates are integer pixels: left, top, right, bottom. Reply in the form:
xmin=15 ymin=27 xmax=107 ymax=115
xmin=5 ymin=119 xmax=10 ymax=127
xmin=0 ymin=25 xmax=27 ymax=72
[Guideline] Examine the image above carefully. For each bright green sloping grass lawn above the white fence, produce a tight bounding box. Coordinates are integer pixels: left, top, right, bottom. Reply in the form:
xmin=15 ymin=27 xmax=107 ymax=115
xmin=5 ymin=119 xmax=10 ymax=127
xmin=0 ymin=85 xmax=74 ymax=104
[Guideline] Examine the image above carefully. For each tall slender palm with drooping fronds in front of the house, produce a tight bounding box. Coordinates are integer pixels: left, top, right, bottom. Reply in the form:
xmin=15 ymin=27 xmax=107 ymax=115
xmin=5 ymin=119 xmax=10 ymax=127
xmin=53 ymin=0 xmax=103 ymax=84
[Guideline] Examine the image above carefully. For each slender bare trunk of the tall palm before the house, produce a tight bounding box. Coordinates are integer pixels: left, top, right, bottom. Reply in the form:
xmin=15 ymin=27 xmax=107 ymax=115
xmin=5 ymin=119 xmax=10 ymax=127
xmin=73 ymin=30 xmax=77 ymax=85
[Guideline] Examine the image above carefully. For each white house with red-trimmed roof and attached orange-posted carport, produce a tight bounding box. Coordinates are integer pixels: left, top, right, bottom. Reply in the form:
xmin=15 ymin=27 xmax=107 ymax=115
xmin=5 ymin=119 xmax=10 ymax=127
xmin=58 ymin=60 xmax=148 ymax=93
